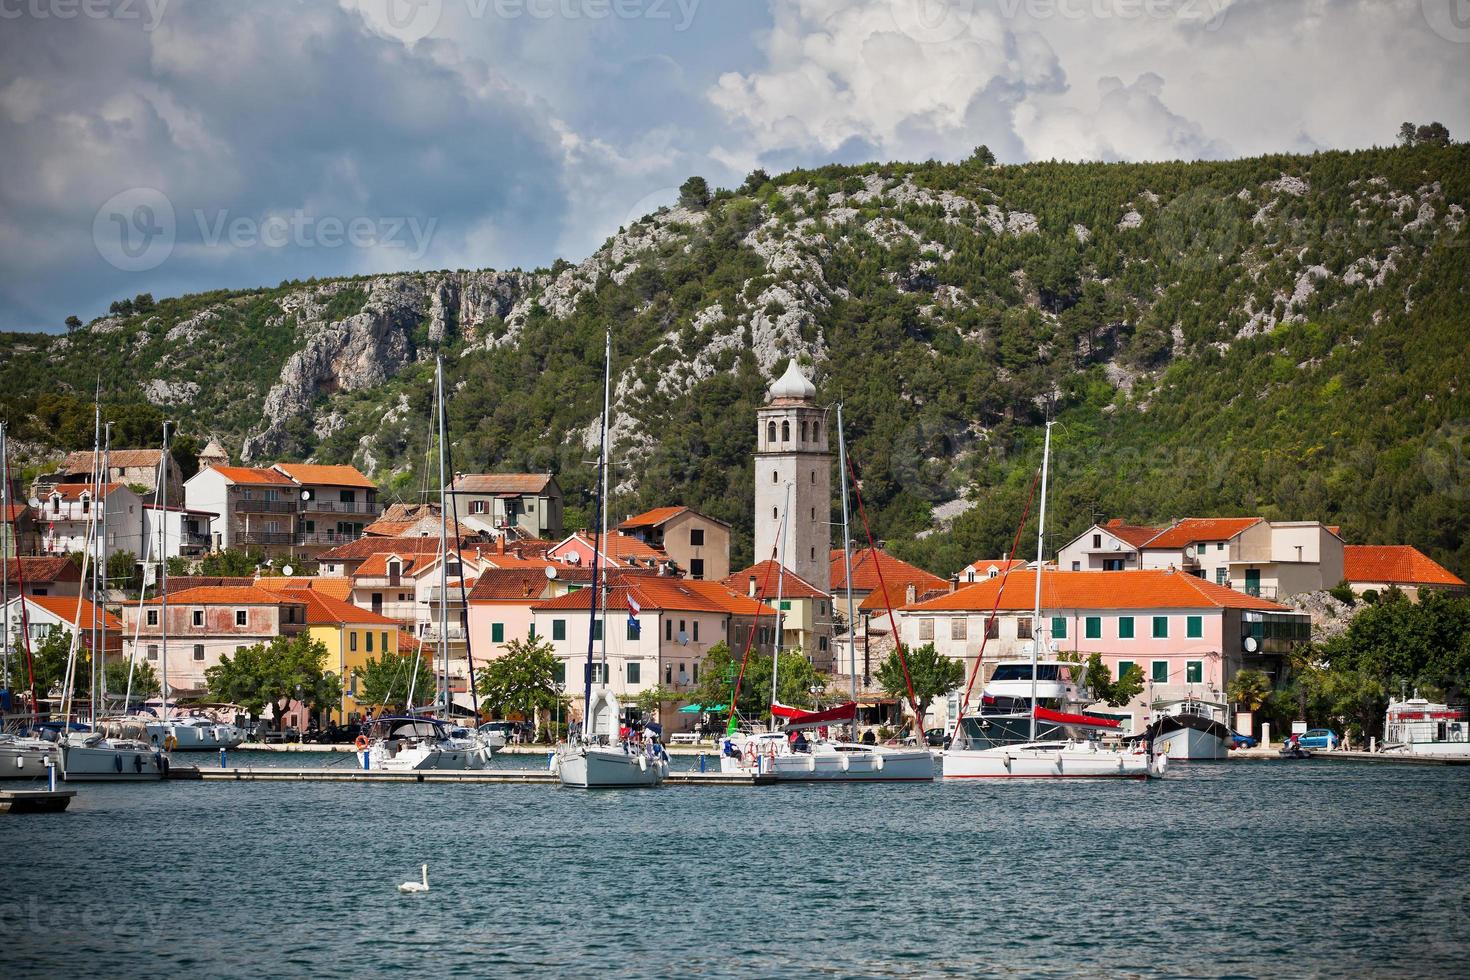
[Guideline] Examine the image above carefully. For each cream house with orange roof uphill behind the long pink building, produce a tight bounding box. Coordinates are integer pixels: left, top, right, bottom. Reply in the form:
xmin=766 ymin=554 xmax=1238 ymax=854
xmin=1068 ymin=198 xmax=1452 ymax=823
xmin=1142 ymin=517 xmax=1344 ymax=599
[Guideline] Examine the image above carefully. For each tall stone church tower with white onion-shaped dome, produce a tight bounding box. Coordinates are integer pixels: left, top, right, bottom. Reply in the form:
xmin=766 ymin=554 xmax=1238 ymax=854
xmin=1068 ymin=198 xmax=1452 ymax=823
xmin=756 ymin=360 xmax=832 ymax=592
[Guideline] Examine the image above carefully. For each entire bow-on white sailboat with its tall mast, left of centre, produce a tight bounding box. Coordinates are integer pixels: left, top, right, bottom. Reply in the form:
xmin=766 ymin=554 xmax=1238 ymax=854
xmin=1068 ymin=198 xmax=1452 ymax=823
xmin=551 ymin=331 xmax=669 ymax=789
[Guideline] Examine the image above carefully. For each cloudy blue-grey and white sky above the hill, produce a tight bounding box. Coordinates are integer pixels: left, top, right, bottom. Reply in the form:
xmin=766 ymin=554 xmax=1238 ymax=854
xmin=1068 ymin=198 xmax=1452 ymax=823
xmin=0 ymin=0 xmax=1470 ymax=331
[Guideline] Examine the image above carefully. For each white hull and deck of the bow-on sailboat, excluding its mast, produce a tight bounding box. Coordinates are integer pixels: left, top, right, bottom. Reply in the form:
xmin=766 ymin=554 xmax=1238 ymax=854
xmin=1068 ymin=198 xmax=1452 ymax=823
xmin=551 ymin=688 xmax=669 ymax=789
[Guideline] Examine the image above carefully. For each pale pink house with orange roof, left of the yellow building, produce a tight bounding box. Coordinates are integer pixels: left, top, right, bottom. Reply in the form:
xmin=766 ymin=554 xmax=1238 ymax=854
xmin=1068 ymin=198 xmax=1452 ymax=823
xmin=122 ymin=586 xmax=307 ymax=698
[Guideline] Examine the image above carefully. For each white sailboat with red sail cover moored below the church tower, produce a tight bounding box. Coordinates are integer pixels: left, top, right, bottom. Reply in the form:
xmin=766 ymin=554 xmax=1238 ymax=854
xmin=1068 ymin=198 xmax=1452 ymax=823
xmin=720 ymin=404 xmax=933 ymax=783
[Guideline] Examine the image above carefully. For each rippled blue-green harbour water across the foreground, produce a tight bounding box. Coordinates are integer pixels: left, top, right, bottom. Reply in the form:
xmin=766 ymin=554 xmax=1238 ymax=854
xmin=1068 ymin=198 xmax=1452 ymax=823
xmin=0 ymin=757 xmax=1470 ymax=977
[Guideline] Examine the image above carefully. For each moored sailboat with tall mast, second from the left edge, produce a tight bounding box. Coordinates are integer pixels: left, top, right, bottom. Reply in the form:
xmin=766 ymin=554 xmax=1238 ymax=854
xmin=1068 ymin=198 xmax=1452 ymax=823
xmin=56 ymin=414 xmax=169 ymax=783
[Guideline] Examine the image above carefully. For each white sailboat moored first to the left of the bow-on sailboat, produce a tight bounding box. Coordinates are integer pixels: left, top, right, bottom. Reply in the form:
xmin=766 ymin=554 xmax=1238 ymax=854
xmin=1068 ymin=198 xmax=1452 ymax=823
xmin=363 ymin=359 xmax=495 ymax=771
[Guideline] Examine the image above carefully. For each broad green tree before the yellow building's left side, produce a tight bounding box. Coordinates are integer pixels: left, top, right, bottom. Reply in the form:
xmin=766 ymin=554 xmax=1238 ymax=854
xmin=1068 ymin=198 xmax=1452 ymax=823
xmin=204 ymin=633 xmax=343 ymax=729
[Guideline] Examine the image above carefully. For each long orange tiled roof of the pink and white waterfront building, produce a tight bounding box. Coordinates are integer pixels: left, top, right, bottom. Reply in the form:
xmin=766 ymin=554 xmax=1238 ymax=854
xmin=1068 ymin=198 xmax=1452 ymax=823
xmin=904 ymin=569 xmax=1289 ymax=613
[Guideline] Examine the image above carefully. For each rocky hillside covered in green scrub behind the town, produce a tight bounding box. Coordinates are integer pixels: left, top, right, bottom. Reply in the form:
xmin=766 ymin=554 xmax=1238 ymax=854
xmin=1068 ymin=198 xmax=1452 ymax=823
xmin=0 ymin=145 xmax=1470 ymax=577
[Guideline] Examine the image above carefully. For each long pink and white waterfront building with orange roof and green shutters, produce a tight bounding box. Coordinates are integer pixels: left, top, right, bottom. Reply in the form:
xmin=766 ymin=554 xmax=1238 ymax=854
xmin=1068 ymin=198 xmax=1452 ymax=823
xmin=898 ymin=569 xmax=1311 ymax=730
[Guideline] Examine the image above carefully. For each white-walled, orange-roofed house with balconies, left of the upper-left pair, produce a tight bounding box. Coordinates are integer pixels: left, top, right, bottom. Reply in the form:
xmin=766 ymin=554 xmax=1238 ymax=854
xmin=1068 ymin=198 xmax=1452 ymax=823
xmin=184 ymin=466 xmax=301 ymax=555
